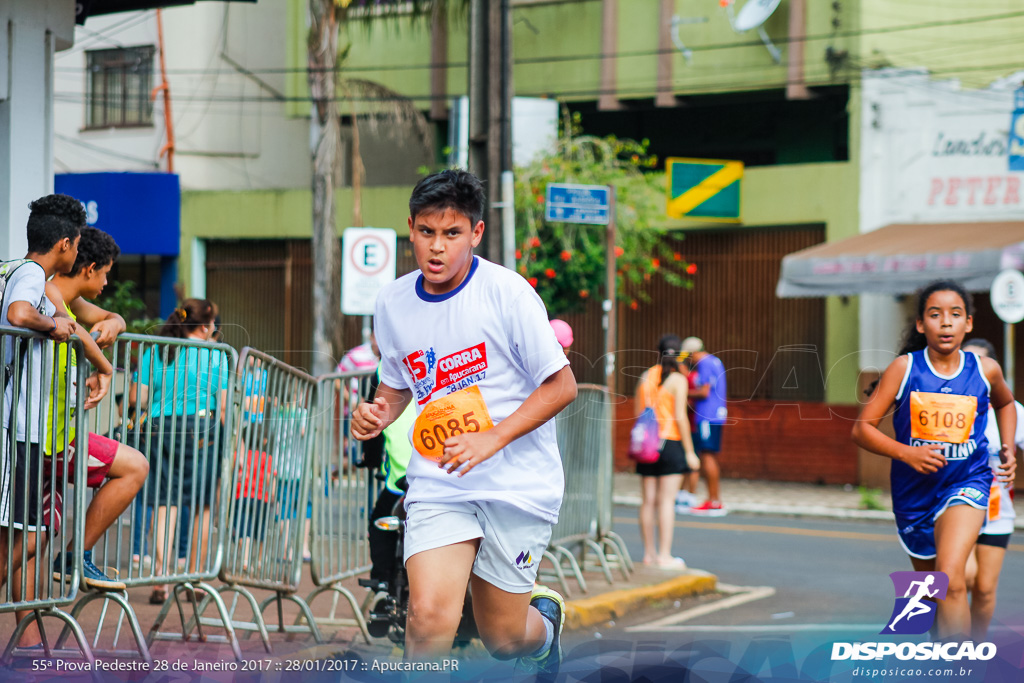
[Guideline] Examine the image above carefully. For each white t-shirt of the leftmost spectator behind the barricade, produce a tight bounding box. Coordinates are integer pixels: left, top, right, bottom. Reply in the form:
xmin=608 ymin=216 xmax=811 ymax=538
xmin=0 ymin=262 xmax=56 ymax=443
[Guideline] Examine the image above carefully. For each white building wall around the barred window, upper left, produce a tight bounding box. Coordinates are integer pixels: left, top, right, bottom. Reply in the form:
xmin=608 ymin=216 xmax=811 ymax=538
xmin=54 ymin=0 xmax=310 ymax=189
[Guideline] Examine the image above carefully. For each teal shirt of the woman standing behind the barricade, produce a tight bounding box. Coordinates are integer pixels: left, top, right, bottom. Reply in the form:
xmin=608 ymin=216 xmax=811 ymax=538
xmin=136 ymin=347 xmax=227 ymax=418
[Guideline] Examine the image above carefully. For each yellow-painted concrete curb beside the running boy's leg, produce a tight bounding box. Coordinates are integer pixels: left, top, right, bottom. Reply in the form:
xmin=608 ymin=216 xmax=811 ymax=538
xmin=564 ymin=573 xmax=718 ymax=631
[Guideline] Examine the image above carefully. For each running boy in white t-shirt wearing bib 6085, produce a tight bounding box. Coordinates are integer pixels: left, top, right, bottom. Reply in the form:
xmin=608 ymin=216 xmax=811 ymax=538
xmin=352 ymin=170 xmax=577 ymax=674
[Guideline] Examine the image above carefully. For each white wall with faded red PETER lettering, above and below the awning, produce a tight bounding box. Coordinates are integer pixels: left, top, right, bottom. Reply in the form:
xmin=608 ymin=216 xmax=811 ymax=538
xmin=860 ymin=70 xmax=1024 ymax=369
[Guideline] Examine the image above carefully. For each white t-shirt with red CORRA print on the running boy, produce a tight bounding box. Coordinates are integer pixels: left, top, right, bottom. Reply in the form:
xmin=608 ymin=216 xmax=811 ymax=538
xmin=374 ymin=257 xmax=568 ymax=524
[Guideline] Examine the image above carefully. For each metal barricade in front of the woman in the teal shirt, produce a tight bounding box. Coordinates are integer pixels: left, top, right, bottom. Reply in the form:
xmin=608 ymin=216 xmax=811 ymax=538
xmin=76 ymin=334 xmax=242 ymax=658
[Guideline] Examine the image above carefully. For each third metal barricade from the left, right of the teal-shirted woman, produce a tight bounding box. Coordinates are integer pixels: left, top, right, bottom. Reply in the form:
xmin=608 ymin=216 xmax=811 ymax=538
xmin=201 ymin=348 xmax=323 ymax=652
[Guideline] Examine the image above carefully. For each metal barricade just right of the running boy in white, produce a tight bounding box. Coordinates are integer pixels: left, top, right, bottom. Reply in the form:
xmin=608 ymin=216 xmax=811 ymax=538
xmin=544 ymin=384 xmax=630 ymax=595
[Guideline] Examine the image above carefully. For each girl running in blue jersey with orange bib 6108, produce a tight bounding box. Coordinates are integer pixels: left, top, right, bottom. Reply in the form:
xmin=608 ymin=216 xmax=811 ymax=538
xmin=853 ymin=281 xmax=1017 ymax=638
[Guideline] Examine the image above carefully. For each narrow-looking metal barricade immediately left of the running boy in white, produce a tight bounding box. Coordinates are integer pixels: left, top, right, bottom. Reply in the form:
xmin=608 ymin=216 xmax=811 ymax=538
xmin=306 ymin=373 xmax=379 ymax=643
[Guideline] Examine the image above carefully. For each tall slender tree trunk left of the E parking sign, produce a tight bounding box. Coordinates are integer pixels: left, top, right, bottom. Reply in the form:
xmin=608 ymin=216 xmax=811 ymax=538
xmin=308 ymin=0 xmax=341 ymax=375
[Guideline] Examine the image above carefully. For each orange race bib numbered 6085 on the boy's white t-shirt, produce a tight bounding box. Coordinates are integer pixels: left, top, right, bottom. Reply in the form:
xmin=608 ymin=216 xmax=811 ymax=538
xmin=413 ymin=385 xmax=495 ymax=461
